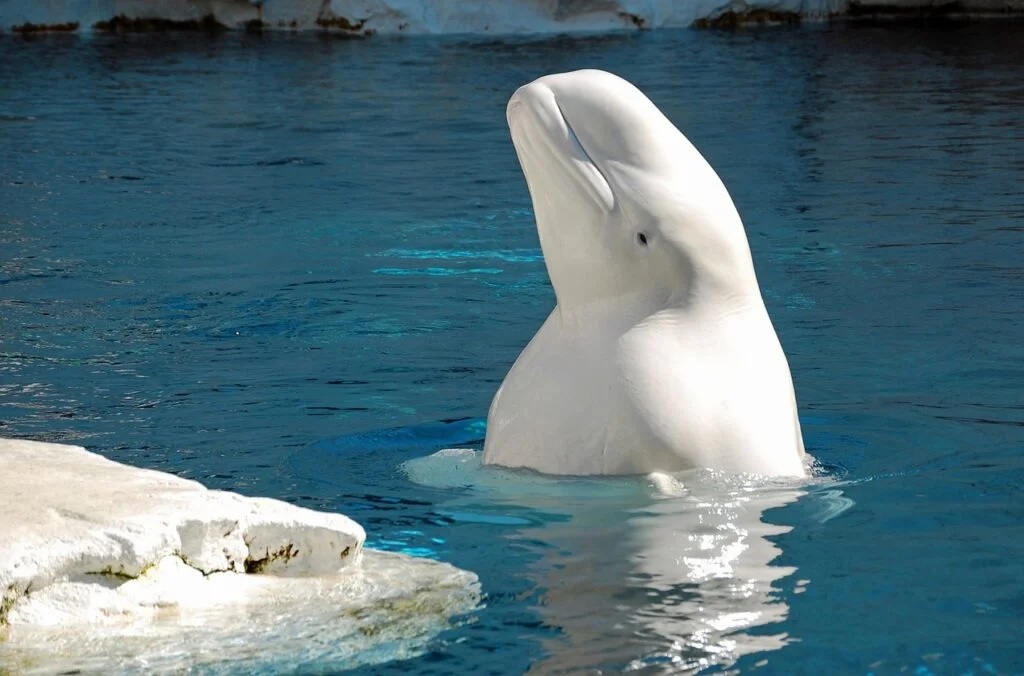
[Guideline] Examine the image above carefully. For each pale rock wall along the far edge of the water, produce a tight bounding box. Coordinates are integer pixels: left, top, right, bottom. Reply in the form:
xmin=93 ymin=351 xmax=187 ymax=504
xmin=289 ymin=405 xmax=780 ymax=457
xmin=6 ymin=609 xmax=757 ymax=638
xmin=0 ymin=0 xmax=1024 ymax=35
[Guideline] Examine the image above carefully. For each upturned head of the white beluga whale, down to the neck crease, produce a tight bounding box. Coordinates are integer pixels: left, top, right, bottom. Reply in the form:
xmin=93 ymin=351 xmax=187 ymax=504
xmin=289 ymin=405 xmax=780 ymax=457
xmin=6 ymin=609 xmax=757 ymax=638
xmin=506 ymin=70 xmax=760 ymax=309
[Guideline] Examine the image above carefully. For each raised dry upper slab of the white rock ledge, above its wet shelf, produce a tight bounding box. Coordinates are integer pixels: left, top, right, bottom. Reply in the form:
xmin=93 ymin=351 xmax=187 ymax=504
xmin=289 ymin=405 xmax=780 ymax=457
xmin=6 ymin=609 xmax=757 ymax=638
xmin=0 ymin=439 xmax=366 ymax=623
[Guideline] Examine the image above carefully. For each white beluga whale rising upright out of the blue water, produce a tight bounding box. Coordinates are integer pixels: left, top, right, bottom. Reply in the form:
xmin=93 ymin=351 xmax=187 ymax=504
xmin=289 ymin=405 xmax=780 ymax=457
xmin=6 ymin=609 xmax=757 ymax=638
xmin=483 ymin=70 xmax=806 ymax=476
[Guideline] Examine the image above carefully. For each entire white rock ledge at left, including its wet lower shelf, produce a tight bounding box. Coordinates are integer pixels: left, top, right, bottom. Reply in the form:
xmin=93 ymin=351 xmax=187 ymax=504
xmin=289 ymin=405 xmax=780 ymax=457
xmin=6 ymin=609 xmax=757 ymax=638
xmin=0 ymin=439 xmax=478 ymax=671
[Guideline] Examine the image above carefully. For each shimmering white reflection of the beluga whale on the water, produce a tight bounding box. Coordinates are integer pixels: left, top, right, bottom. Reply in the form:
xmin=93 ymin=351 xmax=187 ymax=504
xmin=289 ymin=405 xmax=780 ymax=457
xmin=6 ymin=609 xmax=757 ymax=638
xmin=404 ymin=450 xmax=807 ymax=673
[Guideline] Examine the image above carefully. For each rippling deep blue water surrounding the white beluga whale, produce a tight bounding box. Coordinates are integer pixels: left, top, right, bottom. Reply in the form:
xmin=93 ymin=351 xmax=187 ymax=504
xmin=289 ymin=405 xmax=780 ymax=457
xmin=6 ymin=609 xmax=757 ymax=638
xmin=0 ymin=24 xmax=1024 ymax=674
